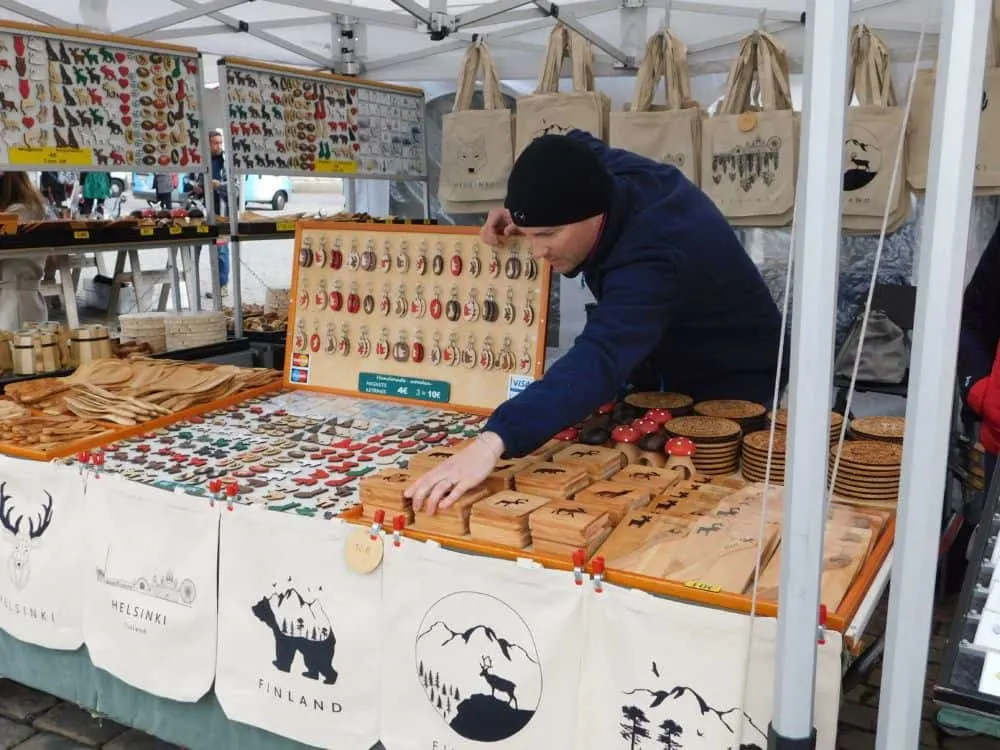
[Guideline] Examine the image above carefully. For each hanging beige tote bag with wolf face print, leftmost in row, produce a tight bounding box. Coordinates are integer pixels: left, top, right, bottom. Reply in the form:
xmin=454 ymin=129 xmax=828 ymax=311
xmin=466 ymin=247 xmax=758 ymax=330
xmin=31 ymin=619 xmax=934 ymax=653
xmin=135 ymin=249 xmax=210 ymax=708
xmin=438 ymin=40 xmax=514 ymax=213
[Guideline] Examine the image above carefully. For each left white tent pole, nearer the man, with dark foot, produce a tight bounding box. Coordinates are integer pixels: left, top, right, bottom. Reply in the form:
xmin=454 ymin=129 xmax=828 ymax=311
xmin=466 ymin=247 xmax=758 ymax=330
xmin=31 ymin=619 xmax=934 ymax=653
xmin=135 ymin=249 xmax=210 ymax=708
xmin=768 ymin=0 xmax=851 ymax=750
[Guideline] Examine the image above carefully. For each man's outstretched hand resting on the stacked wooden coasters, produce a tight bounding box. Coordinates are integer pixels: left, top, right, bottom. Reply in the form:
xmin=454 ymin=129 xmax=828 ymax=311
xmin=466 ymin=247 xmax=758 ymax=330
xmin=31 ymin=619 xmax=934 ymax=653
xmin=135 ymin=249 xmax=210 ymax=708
xmin=403 ymin=432 xmax=503 ymax=515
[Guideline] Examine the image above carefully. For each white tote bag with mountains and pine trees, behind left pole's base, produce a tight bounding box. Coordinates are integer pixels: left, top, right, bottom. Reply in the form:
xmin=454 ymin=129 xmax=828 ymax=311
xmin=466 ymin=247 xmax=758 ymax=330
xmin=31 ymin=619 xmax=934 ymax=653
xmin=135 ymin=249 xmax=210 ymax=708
xmin=574 ymin=585 xmax=842 ymax=750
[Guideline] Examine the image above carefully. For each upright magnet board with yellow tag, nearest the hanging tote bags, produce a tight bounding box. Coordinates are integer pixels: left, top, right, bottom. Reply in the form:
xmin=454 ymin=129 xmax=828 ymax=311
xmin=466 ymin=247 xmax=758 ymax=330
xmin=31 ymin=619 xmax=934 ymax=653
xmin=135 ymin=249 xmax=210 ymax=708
xmin=219 ymin=57 xmax=427 ymax=180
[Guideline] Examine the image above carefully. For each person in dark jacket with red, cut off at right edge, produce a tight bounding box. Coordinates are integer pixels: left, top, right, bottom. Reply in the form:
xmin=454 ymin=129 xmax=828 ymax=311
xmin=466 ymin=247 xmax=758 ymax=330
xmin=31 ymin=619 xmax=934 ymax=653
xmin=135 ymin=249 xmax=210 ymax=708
xmin=958 ymin=220 xmax=1000 ymax=473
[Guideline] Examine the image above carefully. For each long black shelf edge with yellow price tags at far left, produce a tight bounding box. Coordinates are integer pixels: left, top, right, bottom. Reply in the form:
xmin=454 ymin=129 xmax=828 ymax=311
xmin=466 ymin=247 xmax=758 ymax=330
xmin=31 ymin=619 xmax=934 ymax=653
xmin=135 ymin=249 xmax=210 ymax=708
xmin=0 ymin=221 xmax=219 ymax=257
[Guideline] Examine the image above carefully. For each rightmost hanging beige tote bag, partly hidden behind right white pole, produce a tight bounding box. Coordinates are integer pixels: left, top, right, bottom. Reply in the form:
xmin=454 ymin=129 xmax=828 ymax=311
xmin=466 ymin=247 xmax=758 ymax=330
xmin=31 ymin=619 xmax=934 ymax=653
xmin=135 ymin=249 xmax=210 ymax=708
xmin=906 ymin=2 xmax=1000 ymax=195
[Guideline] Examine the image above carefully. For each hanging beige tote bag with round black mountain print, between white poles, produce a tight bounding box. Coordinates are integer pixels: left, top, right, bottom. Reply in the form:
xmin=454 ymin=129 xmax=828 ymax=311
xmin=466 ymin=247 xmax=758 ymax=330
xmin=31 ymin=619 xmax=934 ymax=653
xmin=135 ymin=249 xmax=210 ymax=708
xmin=842 ymin=25 xmax=910 ymax=234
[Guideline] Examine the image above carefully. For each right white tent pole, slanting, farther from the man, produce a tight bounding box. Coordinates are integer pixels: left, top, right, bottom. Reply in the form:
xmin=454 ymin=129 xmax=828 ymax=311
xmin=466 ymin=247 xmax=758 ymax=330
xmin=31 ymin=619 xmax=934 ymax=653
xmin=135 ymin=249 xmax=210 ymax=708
xmin=876 ymin=0 xmax=992 ymax=750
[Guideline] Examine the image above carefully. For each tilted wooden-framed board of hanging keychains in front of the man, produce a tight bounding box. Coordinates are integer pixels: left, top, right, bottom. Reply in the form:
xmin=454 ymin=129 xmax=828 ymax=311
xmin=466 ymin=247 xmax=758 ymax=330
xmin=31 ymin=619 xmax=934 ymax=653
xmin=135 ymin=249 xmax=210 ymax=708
xmin=285 ymin=221 xmax=551 ymax=414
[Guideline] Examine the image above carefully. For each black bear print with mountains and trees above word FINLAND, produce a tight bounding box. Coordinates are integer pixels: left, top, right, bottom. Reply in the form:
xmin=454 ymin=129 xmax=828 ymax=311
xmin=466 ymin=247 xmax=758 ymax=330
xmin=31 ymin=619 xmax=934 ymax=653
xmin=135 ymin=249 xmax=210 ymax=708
xmin=251 ymin=588 xmax=337 ymax=685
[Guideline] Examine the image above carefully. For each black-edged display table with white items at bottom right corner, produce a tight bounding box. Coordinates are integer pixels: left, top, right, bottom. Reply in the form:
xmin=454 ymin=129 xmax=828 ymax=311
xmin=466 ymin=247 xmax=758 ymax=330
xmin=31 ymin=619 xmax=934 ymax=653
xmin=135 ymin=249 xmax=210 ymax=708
xmin=934 ymin=472 xmax=1000 ymax=717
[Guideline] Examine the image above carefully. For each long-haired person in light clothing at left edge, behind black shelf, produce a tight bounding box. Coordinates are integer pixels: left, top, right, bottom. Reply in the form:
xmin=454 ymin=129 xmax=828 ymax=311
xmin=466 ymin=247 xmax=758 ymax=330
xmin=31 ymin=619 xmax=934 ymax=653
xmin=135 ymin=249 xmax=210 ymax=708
xmin=0 ymin=172 xmax=49 ymax=331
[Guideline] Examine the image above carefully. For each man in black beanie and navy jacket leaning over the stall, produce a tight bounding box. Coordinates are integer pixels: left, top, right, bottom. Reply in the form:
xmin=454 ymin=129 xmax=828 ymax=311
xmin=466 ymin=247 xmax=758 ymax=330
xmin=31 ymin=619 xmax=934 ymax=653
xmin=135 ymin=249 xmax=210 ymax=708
xmin=407 ymin=130 xmax=781 ymax=512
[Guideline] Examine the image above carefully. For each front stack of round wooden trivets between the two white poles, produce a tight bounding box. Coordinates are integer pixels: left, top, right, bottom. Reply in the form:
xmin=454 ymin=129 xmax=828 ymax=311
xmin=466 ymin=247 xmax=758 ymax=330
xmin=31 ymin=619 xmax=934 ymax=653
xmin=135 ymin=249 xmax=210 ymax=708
xmin=828 ymin=440 xmax=903 ymax=507
